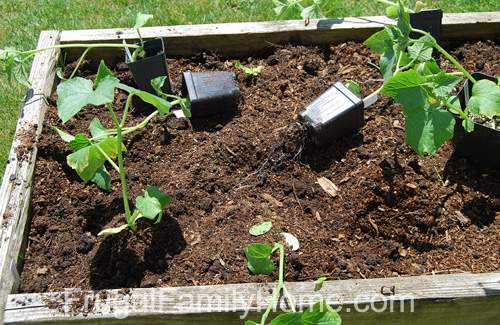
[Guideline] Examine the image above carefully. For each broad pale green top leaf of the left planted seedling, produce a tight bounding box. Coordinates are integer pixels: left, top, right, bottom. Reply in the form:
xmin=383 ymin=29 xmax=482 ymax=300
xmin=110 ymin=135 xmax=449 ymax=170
xmin=57 ymin=76 xmax=119 ymax=123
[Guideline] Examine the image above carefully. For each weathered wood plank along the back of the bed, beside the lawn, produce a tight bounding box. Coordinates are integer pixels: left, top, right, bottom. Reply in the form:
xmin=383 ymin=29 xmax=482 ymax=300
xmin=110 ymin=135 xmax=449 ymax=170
xmin=61 ymin=12 xmax=500 ymax=59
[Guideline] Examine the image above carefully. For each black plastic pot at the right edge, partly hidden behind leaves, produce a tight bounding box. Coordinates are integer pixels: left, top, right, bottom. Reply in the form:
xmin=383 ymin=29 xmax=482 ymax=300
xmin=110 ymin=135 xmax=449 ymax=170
xmin=453 ymin=72 xmax=500 ymax=169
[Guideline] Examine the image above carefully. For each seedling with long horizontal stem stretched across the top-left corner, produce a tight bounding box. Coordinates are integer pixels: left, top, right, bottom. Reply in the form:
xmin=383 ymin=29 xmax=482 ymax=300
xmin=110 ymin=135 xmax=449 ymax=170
xmin=0 ymin=13 xmax=153 ymax=87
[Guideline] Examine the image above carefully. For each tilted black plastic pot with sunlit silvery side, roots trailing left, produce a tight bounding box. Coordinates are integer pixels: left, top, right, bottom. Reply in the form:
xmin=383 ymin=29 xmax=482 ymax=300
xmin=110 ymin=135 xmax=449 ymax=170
xmin=300 ymin=82 xmax=364 ymax=146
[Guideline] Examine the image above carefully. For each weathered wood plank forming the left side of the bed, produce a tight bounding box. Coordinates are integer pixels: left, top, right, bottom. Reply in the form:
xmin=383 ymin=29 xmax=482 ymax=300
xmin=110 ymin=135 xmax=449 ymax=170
xmin=0 ymin=31 xmax=59 ymax=320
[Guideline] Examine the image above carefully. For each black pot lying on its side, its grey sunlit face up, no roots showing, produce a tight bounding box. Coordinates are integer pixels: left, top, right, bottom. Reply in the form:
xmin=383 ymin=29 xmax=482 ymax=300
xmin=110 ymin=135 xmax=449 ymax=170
xmin=182 ymin=71 xmax=241 ymax=117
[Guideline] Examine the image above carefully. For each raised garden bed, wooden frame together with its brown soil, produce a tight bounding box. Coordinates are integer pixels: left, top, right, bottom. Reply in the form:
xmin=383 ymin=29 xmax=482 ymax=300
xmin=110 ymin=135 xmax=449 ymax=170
xmin=0 ymin=13 xmax=500 ymax=324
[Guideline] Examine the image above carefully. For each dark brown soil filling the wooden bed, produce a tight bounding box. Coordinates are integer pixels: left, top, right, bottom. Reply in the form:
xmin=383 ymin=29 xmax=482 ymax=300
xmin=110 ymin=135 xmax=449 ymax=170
xmin=21 ymin=42 xmax=500 ymax=292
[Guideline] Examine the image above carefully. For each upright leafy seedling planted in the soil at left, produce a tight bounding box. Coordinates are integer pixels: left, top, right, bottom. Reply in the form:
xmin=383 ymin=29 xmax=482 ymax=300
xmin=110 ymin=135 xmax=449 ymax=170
xmin=55 ymin=61 xmax=190 ymax=236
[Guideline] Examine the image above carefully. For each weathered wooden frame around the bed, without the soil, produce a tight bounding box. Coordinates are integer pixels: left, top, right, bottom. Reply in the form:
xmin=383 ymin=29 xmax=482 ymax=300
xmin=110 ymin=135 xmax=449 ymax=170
xmin=0 ymin=12 xmax=500 ymax=324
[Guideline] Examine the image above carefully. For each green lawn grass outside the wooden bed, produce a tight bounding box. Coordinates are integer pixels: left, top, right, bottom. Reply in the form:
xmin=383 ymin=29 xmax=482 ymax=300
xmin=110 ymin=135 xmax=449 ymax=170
xmin=0 ymin=0 xmax=500 ymax=179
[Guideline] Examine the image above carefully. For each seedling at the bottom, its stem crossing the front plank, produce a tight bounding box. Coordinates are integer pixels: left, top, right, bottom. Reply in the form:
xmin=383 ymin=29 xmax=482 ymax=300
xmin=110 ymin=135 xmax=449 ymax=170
xmin=243 ymin=227 xmax=342 ymax=325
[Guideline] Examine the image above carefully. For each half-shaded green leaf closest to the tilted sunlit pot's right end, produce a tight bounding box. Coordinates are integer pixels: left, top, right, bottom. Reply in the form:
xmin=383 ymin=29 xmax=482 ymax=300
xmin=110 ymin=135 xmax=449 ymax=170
xmin=381 ymin=70 xmax=428 ymax=109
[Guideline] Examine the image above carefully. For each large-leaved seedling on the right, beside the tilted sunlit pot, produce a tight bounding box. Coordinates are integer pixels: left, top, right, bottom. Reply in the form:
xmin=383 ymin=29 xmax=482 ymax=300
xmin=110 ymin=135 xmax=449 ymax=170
xmin=364 ymin=0 xmax=500 ymax=156
